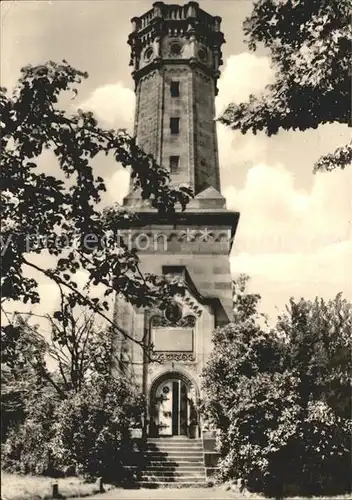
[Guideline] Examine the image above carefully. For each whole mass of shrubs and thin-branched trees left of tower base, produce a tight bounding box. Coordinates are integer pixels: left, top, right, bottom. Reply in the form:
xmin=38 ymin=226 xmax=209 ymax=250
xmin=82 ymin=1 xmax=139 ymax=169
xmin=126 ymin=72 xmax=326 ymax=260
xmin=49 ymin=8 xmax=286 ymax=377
xmin=1 ymin=306 xmax=145 ymax=480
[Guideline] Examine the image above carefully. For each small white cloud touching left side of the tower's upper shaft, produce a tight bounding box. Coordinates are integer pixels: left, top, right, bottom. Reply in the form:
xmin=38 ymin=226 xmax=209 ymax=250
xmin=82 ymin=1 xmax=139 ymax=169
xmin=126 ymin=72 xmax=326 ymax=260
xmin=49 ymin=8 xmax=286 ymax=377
xmin=79 ymin=82 xmax=135 ymax=133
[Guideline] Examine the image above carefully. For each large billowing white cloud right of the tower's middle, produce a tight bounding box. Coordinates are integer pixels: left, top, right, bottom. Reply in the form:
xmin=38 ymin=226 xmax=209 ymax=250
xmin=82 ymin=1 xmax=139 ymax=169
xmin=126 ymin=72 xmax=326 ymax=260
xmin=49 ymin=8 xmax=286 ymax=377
xmin=224 ymin=164 xmax=352 ymax=314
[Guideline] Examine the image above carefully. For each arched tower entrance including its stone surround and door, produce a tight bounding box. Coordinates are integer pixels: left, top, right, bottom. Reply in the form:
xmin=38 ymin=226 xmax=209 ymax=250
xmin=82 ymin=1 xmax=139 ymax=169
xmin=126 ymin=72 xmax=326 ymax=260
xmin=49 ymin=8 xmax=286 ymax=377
xmin=149 ymin=373 xmax=198 ymax=437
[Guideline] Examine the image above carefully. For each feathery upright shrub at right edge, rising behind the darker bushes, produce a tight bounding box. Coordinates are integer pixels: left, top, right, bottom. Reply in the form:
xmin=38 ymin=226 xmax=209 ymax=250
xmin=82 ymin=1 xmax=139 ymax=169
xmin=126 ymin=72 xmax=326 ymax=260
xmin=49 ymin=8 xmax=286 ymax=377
xmin=276 ymin=294 xmax=352 ymax=418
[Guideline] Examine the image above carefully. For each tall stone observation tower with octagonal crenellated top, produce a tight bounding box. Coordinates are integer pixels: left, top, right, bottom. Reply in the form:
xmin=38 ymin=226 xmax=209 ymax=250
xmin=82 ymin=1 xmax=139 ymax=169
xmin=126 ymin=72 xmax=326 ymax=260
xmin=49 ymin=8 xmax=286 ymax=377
xmin=115 ymin=2 xmax=239 ymax=460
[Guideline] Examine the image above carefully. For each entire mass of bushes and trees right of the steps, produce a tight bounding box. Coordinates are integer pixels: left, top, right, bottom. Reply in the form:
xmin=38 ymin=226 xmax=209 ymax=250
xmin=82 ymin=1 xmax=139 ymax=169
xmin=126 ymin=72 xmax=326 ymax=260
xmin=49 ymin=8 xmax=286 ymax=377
xmin=203 ymin=284 xmax=352 ymax=495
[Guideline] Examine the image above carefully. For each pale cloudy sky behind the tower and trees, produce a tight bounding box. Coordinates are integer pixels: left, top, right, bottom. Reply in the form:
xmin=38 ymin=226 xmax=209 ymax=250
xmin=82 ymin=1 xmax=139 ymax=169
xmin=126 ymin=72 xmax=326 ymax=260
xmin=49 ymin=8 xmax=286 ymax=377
xmin=0 ymin=0 xmax=352 ymax=318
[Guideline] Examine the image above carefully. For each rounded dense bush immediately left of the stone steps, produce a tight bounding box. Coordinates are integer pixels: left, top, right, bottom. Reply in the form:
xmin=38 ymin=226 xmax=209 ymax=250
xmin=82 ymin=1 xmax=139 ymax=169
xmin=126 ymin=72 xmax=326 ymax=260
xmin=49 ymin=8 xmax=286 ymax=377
xmin=52 ymin=380 xmax=143 ymax=480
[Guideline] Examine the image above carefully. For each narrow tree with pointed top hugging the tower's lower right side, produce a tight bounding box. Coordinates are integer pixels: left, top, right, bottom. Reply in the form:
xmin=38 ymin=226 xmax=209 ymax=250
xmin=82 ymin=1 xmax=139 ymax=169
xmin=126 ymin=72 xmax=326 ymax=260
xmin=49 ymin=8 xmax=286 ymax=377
xmin=202 ymin=274 xmax=278 ymax=436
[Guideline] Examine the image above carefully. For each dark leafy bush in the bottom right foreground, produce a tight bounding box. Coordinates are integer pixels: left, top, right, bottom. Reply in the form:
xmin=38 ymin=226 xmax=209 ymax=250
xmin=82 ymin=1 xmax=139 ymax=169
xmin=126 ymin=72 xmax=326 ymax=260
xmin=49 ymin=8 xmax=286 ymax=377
xmin=220 ymin=372 xmax=350 ymax=495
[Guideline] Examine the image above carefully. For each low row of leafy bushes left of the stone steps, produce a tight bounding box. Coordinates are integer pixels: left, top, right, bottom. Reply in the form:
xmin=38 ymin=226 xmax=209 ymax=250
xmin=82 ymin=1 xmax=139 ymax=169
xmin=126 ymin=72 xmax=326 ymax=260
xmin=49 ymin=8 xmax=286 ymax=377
xmin=3 ymin=376 xmax=143 ymax=480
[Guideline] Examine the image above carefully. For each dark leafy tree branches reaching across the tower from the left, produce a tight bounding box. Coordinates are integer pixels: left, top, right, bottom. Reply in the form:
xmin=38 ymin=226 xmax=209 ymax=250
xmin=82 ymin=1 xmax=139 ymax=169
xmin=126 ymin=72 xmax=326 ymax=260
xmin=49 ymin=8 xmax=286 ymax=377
xmin=0 ymin=61 xmax=191 ymax=348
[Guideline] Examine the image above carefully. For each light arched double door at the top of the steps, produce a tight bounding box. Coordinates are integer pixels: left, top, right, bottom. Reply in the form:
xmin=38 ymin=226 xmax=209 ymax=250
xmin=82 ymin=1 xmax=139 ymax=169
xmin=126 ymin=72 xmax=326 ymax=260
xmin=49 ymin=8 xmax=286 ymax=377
xmin=154 ymin=378 xmax=190 ymax=436
